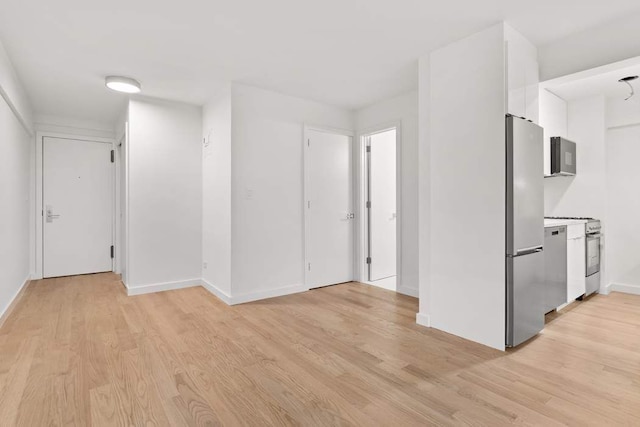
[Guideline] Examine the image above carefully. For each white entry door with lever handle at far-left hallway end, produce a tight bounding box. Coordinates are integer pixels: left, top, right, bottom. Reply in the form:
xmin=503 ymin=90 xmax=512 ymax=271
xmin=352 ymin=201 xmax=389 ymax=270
xmin=42 ymin=137 xmax=113 ymax=277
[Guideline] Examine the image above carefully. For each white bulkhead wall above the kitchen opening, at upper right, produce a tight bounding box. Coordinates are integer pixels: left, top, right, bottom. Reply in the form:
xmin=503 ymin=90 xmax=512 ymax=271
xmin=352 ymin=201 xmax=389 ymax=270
xmin=538 ymin=14 xmax=640 ymax=81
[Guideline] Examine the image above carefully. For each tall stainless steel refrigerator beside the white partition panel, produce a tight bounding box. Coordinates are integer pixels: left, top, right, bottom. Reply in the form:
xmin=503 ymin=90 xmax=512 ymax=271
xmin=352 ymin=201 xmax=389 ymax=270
xmin=506 ymin=115 xmax=545 ymax=347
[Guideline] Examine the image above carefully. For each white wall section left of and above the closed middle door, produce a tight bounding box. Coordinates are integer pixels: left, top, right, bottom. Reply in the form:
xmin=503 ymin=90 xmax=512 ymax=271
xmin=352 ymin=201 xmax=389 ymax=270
xmin=231 ymin=84 xmax=354 ymax=301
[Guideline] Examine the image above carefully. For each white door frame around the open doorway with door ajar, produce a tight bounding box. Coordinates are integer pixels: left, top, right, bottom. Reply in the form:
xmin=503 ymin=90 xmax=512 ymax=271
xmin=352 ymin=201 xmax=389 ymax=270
xmin=356 ymin=120 xmax=403 ymax=293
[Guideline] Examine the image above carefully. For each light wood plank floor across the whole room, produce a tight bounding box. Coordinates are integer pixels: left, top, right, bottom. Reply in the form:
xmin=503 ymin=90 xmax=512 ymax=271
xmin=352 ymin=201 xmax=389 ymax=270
xmin=0 ymin=274 xmax=640 ymax=426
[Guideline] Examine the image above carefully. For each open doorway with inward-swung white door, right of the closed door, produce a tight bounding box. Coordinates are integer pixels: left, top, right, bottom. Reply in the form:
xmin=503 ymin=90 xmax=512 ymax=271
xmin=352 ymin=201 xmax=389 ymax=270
xmin=361 ymin=126 xmax=399 ymax=290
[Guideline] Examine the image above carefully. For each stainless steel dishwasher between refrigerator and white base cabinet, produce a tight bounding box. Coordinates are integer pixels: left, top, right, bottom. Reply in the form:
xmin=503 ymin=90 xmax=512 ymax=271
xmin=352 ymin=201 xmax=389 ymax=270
xmin=544 ymin=226 xmax=567 ymax=313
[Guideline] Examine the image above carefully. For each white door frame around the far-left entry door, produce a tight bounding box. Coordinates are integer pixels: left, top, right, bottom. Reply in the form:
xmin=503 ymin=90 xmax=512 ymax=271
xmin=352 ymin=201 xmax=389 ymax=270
xmin=34 ymin=131 xmax=116 ymax=280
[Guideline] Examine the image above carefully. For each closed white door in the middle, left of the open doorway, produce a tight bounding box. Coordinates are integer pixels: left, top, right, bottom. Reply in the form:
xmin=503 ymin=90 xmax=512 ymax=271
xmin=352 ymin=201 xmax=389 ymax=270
xmin=305 ymin=130 xmax=355 ymax=288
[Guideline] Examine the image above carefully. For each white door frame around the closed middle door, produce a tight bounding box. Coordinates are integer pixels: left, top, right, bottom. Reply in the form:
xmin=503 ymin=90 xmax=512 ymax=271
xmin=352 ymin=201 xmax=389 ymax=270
xmin=302 ymin=124 xmax=359 ymax=290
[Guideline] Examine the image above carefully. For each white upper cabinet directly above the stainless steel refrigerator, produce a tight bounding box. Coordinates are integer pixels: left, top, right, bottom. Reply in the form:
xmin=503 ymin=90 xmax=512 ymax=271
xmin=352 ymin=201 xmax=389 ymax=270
xmin=505 ymin=25 xmax=539 ymax=123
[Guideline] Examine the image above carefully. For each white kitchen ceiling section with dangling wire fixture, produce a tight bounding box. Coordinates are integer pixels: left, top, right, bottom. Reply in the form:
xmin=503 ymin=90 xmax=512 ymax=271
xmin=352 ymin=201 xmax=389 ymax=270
xmin=547 ymin=64 xmax=640 ymax=101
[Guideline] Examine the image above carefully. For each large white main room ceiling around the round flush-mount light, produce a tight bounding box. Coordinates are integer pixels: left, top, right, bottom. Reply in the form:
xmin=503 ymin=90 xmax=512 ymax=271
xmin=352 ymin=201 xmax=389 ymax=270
xmin=0 ymin=0 xmax=640 ymax=121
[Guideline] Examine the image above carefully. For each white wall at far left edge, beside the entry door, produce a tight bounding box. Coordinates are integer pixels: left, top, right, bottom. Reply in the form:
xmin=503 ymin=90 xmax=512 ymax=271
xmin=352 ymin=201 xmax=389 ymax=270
xmin=0 ymin=41 xmax=35 ymax=316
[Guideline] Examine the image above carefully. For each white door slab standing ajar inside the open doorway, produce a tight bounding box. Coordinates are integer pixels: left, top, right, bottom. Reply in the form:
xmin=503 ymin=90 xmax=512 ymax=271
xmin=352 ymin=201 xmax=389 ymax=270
xmin=367 ymin=129 xmax=397 ymax=282
